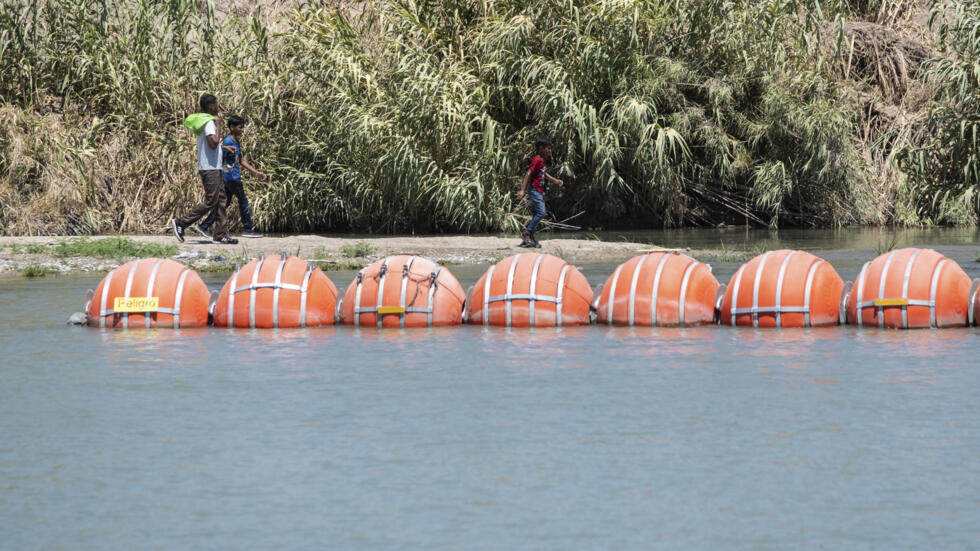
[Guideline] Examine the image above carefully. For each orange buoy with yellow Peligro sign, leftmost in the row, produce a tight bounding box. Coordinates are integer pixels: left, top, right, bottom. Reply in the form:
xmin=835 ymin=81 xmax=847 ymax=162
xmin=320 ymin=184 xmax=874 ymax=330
xmin=85 ymin=258 xmax=209 ymax=329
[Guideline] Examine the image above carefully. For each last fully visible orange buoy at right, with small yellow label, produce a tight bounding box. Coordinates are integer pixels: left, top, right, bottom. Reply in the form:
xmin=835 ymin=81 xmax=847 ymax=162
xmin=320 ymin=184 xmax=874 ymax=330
xmin=847 ymin=248 xmax=970 ymax=329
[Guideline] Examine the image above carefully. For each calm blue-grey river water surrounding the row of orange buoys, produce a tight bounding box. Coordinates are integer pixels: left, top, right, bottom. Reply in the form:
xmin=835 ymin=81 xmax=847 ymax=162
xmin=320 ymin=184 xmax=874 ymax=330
xmin=0 ymin=231 xmax=980 ymax=550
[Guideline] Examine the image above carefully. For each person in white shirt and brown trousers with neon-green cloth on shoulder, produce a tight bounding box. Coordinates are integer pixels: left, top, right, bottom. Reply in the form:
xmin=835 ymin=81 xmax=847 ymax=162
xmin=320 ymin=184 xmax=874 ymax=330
xmin=171 ymin=94 xmax=238 ymax=245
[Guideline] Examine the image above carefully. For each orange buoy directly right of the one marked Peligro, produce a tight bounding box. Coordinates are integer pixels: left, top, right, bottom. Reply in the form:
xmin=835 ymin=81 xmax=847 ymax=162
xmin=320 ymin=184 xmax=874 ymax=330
xmin=214 ymin=253 xmax=337 ymax=328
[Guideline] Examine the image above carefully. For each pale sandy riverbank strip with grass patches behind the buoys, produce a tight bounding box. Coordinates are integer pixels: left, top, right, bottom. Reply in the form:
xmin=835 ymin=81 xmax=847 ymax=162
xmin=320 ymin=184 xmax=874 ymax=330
xmin=0 ymin=234 xmax=696 ymax=276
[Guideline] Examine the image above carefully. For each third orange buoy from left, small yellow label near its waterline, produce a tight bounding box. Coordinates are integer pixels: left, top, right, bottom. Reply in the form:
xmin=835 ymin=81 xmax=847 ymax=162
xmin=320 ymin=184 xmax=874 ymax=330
xmin=340 ymin=254 xmax=466 ymax=327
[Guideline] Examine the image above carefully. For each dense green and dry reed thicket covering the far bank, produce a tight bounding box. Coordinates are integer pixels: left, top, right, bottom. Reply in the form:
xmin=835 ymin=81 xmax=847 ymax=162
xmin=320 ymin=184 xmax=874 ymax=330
xmin=0 ymin=0 xmax=980 ymax=234
